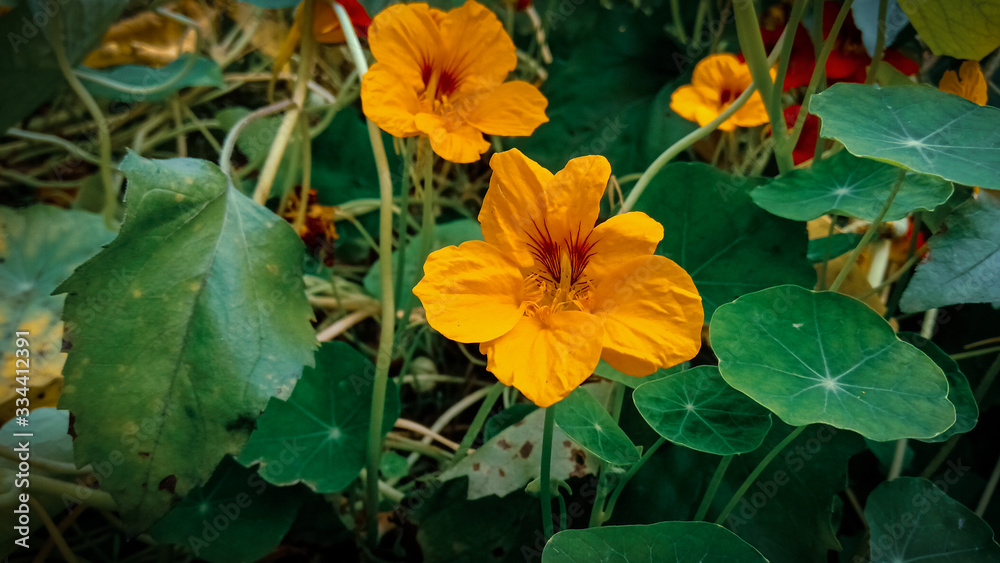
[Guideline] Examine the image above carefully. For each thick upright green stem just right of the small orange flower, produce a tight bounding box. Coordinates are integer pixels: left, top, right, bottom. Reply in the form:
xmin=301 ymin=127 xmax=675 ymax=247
xmin=733 ymin=1 xmax=795 ymax=173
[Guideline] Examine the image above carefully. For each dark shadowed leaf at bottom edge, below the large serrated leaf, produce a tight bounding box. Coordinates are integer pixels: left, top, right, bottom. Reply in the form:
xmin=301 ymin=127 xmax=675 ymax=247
xmin=149 ymin=457 xmax=306 ymax=563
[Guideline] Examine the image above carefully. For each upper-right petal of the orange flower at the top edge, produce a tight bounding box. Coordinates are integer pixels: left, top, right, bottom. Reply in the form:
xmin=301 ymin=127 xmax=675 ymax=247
xmin=439 ymin=1 xmax=517 ymax=94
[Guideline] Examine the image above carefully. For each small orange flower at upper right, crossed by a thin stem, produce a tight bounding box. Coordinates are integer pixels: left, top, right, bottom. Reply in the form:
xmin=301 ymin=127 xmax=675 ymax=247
xmin=670 ymin=53 xmax=773 ymax=131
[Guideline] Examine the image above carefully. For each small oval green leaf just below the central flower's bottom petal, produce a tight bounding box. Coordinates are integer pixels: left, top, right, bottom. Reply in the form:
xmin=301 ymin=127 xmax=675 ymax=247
xmin=555 ymin=385 xmax=639 ymax=465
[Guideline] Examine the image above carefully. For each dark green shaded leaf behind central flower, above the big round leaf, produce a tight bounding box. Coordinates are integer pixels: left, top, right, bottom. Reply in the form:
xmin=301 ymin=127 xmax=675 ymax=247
xmin=635 ymin=163 xmax=816 ymax=322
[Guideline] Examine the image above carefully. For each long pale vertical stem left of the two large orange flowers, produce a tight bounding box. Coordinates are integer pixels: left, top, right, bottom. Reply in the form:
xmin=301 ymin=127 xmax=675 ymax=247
xmin=336 ymin=2 xmax=396 ymax=548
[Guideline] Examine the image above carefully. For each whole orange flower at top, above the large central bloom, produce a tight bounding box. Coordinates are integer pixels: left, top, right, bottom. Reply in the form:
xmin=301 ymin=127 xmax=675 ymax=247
xmin=361 ymin=0 xmax=548 ymax=162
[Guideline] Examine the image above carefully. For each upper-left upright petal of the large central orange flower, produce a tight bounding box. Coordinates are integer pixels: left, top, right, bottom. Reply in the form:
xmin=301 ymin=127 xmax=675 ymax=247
xmin=479 ymin=149 xmax=553 ymax=268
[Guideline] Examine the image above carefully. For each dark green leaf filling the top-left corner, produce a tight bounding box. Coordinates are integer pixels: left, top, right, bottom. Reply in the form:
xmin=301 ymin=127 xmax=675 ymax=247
xmin=0 ymin=0 xmax=128 ymax=134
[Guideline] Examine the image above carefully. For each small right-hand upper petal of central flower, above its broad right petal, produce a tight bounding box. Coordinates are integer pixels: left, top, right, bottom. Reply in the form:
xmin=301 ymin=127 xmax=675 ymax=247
xmin=586 ymin=211 xmax=663 ymax=282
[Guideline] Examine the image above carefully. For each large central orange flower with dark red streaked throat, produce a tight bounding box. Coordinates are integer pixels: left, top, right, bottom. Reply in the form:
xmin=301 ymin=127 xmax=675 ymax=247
xmin=413 ymin=150 xmax=704 ymax=407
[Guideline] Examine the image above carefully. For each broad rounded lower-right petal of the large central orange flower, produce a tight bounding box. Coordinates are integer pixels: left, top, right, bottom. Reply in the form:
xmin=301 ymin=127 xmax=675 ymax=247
xmin=591 ymin=256 xmax=705 ymax=376
